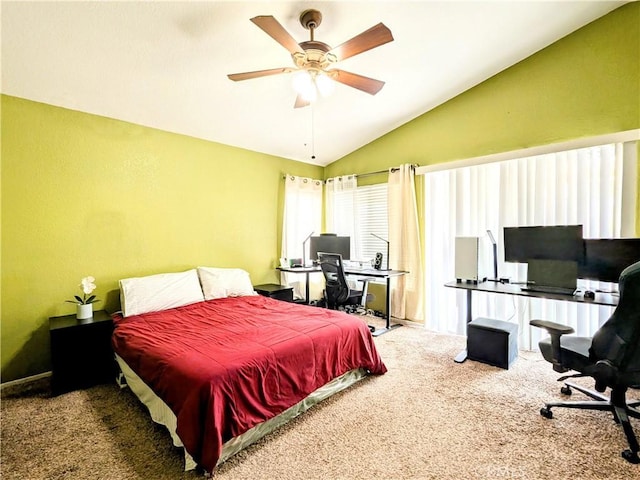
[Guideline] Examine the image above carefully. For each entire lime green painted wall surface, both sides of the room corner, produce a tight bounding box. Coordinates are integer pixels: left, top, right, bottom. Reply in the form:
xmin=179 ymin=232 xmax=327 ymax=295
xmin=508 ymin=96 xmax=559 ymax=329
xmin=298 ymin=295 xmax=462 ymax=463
xmin=0 ymin=3 xmax=640 ymax=382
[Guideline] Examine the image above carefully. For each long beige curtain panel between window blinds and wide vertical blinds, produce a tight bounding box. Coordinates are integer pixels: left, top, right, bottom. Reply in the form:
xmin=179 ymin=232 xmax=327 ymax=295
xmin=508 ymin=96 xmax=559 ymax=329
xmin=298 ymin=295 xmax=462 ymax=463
xmin=388 ymin=165 xmax=424 ymax=321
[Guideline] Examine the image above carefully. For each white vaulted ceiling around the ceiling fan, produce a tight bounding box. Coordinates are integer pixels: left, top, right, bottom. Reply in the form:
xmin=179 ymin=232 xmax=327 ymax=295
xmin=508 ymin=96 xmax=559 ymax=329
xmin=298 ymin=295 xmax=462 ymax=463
xmin=1 ymin=0 xmax=627 ymax=165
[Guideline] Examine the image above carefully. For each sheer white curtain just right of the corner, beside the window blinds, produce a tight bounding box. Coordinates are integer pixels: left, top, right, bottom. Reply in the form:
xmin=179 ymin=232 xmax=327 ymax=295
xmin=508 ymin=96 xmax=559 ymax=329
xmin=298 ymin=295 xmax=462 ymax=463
xmin=325 ymin=175 xmax=360 ymax=258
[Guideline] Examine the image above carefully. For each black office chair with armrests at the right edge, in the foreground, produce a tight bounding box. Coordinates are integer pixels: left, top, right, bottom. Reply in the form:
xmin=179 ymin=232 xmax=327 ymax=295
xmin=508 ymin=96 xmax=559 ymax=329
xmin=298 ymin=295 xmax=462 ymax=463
xmin=530 ymin=262 xmax=640 ymax=463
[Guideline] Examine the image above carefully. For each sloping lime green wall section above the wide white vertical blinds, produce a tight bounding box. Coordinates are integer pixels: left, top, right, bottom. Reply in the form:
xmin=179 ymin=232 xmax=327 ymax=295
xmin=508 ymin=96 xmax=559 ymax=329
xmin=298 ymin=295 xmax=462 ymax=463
xmin=325 ymin=3 xmax=640 ymax=186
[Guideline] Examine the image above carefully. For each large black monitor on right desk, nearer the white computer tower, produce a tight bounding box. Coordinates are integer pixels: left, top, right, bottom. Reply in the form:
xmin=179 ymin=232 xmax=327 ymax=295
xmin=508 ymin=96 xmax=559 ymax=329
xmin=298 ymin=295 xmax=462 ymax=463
xmin=504 ymin=225 xmax=585 ymax=264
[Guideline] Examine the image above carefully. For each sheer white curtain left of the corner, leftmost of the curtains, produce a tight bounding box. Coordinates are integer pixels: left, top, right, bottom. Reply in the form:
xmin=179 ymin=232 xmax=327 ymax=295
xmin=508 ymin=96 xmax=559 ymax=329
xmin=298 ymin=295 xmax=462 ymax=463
xmin=280 ymin=175 xmax=322 ymax=298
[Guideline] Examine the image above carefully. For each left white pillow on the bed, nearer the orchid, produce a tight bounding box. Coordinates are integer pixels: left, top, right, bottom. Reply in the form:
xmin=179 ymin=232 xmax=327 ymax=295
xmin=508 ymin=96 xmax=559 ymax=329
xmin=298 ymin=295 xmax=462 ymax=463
xmin=120 ymin=268 xmax=204 ymax=317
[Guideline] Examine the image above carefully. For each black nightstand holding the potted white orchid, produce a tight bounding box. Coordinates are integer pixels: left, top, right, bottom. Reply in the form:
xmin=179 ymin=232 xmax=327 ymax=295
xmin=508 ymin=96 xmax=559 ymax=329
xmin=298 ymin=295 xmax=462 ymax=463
xmin=49 ymin=310 xmax=116 ymax=395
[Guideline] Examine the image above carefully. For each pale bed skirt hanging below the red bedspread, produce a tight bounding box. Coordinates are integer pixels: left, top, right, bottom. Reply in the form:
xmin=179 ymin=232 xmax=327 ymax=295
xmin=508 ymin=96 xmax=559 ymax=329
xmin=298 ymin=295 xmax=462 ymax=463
xmin=115 ymin=354 xmax=367 ymax=473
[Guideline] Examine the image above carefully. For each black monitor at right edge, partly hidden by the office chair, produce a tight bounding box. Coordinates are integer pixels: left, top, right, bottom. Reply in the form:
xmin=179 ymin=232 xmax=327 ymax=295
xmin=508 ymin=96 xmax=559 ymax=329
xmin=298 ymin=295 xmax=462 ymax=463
xmin=578 ymin=238 xmax=640 ymax=283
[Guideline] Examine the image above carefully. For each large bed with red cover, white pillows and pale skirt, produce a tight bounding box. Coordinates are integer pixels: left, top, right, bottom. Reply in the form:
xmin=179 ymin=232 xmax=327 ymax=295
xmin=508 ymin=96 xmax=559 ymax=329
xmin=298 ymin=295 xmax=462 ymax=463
xmin=112 ymin=267 xmax=386 ymax=473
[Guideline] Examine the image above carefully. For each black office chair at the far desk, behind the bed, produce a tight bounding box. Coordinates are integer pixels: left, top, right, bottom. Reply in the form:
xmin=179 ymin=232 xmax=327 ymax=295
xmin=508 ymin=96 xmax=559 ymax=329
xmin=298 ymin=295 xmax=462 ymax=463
xmin=318 ymin=252 xmax=371 ymax=310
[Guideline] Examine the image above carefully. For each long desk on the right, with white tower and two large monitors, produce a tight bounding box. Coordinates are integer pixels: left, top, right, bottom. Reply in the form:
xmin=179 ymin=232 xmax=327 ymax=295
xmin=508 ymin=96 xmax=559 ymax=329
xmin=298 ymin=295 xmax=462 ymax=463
xmin=444 ymin=281 xmax=618 ymax=363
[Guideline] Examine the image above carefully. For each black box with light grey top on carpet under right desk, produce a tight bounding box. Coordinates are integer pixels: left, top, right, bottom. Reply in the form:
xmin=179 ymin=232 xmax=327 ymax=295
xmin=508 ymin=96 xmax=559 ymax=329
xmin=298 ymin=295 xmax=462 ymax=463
xmin=467 ymin=317 xmax=518 ymax=369
